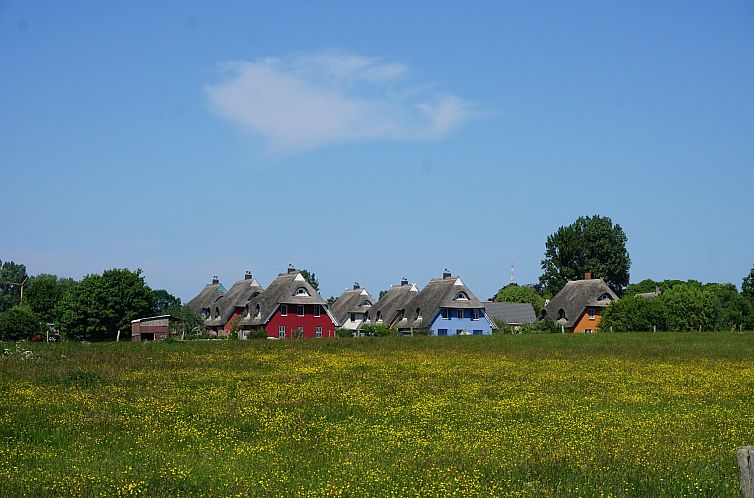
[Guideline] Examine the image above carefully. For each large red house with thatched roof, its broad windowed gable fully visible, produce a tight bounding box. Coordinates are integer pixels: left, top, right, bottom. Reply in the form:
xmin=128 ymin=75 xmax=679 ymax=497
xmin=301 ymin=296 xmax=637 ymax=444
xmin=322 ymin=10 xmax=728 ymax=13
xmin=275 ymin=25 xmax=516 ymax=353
xmin=238 ymin=267 xmax=338 ymax=339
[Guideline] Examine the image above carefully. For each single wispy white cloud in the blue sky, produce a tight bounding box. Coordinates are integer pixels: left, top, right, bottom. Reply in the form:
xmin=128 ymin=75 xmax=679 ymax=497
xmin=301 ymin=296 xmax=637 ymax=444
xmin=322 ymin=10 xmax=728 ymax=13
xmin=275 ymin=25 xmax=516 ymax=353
xmin=205 ymin=51 xmax=475 ymax=154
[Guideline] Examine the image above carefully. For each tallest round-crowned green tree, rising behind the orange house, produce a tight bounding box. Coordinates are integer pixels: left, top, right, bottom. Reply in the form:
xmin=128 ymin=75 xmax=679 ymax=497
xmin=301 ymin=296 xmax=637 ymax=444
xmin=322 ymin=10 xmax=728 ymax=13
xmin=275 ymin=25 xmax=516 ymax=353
xmin=539 ymin=215 xmax=631 ymax=296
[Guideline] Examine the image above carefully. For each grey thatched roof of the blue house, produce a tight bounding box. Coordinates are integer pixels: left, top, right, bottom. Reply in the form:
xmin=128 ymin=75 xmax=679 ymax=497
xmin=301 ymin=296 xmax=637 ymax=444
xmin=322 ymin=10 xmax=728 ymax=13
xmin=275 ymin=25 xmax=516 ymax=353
xmin=385 ymin=275 xmax=494 ymax=329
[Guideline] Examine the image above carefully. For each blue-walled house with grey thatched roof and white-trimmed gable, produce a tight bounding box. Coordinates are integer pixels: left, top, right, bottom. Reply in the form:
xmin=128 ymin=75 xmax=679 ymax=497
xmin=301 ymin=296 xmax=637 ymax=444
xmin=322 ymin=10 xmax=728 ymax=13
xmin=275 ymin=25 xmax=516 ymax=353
xmin=389 ymin=270 xmax=496 ymax=336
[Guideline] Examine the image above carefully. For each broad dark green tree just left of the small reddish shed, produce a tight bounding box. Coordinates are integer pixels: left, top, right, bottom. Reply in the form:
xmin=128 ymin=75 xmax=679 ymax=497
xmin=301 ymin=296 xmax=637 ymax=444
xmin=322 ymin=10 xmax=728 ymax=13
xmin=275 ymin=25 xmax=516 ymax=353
xmin=56 ymin=269 xmax=154 ymax=341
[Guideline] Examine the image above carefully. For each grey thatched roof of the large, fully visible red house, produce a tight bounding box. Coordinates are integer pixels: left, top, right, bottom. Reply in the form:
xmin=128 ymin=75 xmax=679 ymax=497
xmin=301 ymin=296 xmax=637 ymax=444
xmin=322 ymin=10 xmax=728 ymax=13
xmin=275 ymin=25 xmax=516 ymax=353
xmin=239 ymin=272 xmax=337 ymax=327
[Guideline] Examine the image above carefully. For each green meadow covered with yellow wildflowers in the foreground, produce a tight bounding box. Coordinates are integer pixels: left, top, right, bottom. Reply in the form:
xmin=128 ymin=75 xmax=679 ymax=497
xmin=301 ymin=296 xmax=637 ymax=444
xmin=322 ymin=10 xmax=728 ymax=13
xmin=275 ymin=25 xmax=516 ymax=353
xmin=0 ymin=333 xmax=754 ymax=496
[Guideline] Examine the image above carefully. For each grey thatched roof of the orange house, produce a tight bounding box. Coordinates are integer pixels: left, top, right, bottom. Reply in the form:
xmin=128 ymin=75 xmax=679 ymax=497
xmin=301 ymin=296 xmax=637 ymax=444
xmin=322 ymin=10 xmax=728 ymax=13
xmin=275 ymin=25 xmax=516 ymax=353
xmin=545 ymin=278 xmax=618 ymax=327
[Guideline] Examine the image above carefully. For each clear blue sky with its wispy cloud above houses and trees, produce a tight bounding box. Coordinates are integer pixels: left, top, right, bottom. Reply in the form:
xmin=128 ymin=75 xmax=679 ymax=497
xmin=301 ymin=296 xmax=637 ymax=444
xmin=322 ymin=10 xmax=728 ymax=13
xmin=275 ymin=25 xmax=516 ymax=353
xmin=0 ymin=1 xmax=754 ymax=300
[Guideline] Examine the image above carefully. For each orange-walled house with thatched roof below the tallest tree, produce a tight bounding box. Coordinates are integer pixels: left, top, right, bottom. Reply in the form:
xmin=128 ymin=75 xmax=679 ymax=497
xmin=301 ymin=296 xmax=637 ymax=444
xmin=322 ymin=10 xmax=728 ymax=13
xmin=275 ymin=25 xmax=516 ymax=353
xmin=544 ymin=273 xmax=618 ymax=333
